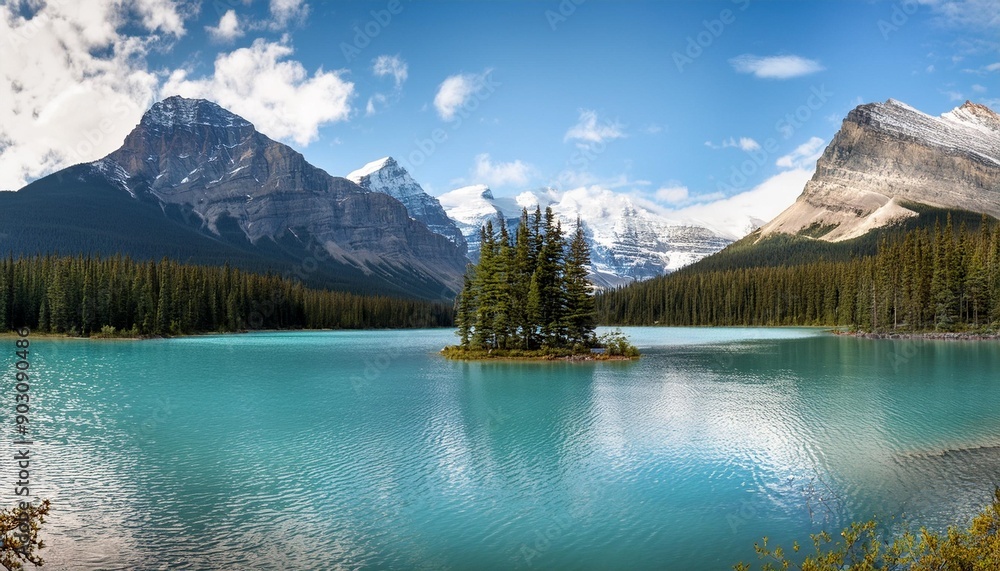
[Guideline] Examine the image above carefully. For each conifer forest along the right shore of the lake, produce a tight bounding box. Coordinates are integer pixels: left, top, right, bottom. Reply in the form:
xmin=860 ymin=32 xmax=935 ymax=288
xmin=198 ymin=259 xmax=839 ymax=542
xmin=596 ymin=218 xmax=1000 ymax=331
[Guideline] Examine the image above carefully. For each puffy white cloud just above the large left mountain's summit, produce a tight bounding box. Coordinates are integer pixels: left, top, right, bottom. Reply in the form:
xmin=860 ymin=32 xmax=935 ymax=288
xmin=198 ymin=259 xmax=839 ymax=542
xmin=163 ymin=39 xmax=354 ymax=145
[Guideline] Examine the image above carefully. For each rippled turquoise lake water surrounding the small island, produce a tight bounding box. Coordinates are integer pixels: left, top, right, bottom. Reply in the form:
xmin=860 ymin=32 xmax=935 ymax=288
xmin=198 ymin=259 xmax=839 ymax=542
xmin=7 ymin=328 xmax=1000 ymax=570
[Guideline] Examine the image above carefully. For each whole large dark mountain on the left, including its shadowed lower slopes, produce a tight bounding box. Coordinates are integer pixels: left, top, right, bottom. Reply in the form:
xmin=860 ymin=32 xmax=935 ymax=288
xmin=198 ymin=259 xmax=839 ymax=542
xmin=0 ymin=97 xmax=466 ymax=298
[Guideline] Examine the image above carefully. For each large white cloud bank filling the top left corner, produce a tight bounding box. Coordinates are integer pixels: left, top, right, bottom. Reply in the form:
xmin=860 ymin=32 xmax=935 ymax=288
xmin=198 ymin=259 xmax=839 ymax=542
xmin=0 ymin=0 xmax=169 ymax=190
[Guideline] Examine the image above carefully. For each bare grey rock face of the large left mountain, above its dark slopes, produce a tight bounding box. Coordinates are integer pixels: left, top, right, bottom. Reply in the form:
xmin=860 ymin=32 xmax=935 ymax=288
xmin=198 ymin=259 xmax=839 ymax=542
xmin=92 ymin=97 xmax=466 ymax=287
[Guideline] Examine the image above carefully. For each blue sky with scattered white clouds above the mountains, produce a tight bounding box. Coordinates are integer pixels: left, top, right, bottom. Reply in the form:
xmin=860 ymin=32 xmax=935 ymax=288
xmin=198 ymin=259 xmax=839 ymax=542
xmin=0 ymin=0 xmax=1000 ymax=235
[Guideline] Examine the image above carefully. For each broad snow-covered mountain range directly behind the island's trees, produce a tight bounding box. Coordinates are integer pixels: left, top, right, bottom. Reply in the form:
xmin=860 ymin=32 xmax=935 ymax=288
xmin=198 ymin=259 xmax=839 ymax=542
xmin=439 ymin=185 xmax=731 ymax=287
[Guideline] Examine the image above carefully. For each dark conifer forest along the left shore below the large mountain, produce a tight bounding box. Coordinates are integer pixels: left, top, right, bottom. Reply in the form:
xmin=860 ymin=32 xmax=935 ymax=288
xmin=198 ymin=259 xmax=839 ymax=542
xmin=0 ymin=256 xmax=453 ymax=336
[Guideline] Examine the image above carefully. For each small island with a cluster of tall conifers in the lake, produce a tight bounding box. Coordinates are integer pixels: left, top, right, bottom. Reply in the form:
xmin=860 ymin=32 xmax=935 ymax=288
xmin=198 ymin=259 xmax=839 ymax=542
xmin=441 ymin=207 xmax=639 ymax=360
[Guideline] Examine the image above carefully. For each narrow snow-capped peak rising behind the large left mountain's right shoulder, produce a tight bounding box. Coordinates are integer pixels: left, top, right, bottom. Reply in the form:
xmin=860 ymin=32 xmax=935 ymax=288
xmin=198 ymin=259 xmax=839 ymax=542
xmin=346 ymin=157 xmax=467 ymax=253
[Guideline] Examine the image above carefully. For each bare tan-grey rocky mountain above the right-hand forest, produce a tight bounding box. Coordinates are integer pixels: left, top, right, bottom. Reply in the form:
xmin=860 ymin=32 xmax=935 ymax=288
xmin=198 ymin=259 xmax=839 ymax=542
xmin=760 ymin=99 xmax=1000 ymax=242
